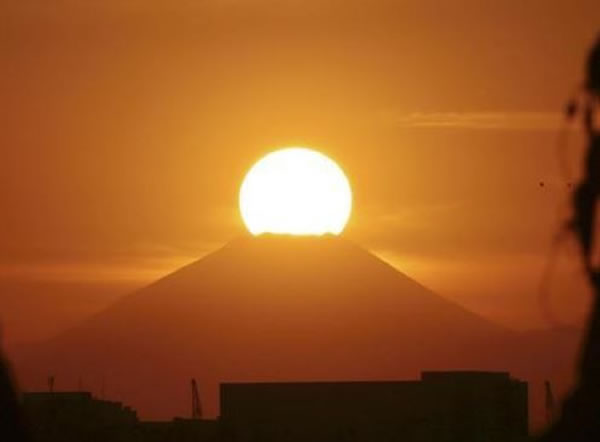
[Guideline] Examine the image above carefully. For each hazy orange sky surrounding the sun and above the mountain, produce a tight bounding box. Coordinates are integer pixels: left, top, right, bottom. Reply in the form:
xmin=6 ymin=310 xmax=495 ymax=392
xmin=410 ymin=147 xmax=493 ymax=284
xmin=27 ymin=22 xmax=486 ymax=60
xmin=0 ymin=0 xmax=600 ymax=340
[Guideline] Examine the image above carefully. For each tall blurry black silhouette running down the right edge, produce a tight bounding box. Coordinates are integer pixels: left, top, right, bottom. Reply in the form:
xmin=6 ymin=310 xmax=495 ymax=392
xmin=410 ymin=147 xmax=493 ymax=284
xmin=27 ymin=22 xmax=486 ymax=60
xmin=540 ymin=33 xmax=600 ymax=442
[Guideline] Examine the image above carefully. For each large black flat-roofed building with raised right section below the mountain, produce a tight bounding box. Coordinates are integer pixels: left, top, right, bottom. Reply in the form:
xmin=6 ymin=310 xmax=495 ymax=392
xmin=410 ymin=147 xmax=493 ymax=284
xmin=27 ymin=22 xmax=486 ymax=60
xmin=221 ymin=371 xmax=528 ymax=442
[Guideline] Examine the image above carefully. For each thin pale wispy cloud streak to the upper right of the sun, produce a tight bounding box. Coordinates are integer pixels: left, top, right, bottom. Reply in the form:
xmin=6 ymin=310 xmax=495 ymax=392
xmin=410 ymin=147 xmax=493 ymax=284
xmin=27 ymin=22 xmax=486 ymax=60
xmin=383 ymin=111 xmax=562 ymax=130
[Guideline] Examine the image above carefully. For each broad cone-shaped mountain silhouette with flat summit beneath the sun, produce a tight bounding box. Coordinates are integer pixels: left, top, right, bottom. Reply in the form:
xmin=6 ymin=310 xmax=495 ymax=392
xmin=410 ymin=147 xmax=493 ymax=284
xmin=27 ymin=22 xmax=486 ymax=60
xmin=12 ymin=235 xmax=576 ymax=424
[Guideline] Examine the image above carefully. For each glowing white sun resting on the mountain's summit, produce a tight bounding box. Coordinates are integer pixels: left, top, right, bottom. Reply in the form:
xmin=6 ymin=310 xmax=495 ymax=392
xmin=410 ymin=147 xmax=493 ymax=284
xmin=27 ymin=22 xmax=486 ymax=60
xmin=240 ymin=147 xmax=352 ymax=235
